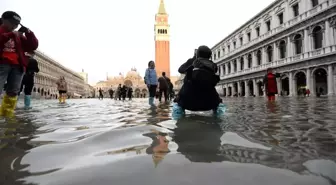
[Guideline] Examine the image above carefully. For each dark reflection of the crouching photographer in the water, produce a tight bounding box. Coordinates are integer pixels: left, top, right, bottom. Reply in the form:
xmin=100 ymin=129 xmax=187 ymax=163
xmin=172 ymin=116 xmax=224 ymax=162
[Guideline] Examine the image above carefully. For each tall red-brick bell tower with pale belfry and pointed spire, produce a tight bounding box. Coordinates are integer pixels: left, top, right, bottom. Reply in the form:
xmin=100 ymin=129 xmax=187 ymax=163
xmin=154 ymin=0 xmax=170 ymax=77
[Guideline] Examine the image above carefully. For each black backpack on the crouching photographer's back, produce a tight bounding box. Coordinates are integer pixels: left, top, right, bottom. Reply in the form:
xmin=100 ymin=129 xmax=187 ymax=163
xmin=191 ymin=58 xmax=220 ymax=87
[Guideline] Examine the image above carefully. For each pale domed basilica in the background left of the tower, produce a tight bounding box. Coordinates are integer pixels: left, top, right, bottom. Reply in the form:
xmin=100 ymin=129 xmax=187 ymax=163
xmin=95 ymin=68 xmax=147 ymax=97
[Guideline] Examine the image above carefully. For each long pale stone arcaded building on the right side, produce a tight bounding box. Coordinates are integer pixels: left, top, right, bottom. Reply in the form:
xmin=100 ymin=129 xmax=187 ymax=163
xmin=212 ymin=0 xmax=336 ymax=96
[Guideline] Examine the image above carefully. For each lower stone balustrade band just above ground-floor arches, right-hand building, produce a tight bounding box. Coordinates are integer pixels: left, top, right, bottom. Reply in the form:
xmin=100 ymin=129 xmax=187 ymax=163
xmin=220 ymin=44 xmax=336 ymax=80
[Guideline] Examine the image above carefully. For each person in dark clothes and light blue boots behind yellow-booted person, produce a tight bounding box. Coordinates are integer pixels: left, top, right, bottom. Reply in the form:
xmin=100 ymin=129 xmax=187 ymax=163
xmin=18 ymin=52 xmax=40 ymax=109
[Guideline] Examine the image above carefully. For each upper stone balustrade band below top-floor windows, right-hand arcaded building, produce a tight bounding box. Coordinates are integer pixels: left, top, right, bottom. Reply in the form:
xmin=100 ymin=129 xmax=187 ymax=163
xmin=215 ymin=0 xmax=336 ymax=63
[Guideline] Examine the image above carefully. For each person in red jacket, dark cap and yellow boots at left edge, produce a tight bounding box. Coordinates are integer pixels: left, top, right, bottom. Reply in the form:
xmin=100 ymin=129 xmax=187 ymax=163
xmin=0 ymin=11 xmax=38 ymax=117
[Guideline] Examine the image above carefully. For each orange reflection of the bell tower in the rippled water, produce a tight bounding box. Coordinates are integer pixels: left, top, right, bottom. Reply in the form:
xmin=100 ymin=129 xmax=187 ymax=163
xmin=144 ymin=131 xmax=170 ymax=167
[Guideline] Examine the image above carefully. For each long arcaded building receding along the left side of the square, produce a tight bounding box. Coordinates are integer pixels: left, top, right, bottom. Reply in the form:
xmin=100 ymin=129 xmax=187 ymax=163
xmin=32 ymin=51 xmax=85 ymax=98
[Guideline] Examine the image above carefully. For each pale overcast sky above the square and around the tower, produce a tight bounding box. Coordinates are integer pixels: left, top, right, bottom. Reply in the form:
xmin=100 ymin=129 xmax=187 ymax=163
xmin=0 ymin=0 xmax=274 ymax=84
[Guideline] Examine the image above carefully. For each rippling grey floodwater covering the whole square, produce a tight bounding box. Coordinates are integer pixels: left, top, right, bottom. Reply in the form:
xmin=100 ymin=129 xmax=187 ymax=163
xmin=0 ymin=98 xmax=336 ymax=185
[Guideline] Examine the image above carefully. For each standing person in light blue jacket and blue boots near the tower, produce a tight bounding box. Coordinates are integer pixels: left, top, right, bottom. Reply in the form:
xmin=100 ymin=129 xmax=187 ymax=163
xmin=145 ymin=61 xmax=158 ymax=107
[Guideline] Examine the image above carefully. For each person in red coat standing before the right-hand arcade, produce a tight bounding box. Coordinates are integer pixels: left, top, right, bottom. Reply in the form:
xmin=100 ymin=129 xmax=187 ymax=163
xmin=264 ymin=68 xmax=280 ymax=101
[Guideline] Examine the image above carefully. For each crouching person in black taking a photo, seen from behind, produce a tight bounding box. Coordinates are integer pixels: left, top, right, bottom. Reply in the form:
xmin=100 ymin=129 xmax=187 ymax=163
xmin=176 ymin=46 xmax=222 ymax=111
